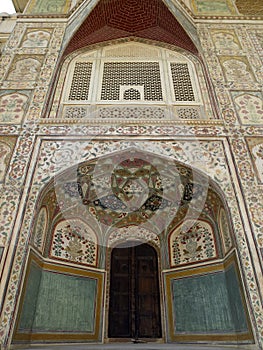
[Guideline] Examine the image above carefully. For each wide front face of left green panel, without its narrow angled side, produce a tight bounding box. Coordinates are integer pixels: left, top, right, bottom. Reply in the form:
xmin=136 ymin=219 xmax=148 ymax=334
xmin=33 ymin=271 xmax=97 ymax=332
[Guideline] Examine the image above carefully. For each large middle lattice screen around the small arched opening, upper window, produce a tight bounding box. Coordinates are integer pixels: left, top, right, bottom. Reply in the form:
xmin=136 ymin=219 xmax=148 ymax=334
xmin=101 ymin=62 xmax=163 ymax=101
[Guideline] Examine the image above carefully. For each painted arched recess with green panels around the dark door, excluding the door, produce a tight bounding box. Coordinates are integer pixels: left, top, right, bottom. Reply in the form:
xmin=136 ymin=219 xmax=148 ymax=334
xmin=15 ymin=147 xmax=253 ymax=343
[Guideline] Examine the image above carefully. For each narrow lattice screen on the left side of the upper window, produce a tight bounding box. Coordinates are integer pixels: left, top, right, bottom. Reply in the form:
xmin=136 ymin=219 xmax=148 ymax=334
xmin=69 ymin=62 xmax=92 ymax=101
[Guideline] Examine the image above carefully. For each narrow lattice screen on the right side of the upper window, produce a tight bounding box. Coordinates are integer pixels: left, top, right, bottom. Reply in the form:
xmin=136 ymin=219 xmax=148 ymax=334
xmin=170 ymin=63 xmax=195 ymax=101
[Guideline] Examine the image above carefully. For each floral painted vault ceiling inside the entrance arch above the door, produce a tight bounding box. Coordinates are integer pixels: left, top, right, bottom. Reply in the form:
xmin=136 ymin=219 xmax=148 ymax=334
xmin=39 ymin=149 xmax=227 ymax=239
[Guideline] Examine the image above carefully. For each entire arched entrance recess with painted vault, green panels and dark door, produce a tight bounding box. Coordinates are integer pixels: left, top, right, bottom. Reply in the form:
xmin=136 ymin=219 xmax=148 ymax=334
xmin=14 ymin=148 xmax=253 ymax=343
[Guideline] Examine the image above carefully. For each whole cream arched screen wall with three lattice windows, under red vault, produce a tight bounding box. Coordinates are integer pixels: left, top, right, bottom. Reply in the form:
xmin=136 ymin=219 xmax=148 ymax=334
xmin=58 ymin=42 xmax=217 ymax=122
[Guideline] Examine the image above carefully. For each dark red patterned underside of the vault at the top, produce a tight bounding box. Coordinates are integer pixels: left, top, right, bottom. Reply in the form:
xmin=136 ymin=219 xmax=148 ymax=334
xmin=64 ymin=0 xmax=198 ymax=55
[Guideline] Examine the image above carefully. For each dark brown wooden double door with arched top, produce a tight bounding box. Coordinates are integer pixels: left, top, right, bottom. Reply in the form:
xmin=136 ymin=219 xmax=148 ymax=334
xmin=108 ymin=242 xmax=162 ymax=339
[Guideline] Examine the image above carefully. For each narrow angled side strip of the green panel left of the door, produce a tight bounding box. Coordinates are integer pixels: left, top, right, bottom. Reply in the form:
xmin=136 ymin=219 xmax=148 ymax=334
xmin=18 ymin=264 xmax=42 ymax=331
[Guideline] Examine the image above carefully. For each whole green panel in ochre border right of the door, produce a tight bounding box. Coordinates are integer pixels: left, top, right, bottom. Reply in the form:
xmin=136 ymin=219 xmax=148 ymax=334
xmin=172 ymin=267 xmax=250 ymax=333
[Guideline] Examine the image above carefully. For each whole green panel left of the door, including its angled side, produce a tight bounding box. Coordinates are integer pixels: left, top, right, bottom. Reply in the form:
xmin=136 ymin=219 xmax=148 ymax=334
xmin=18 ymin=263 xmax=97 ymax=333
